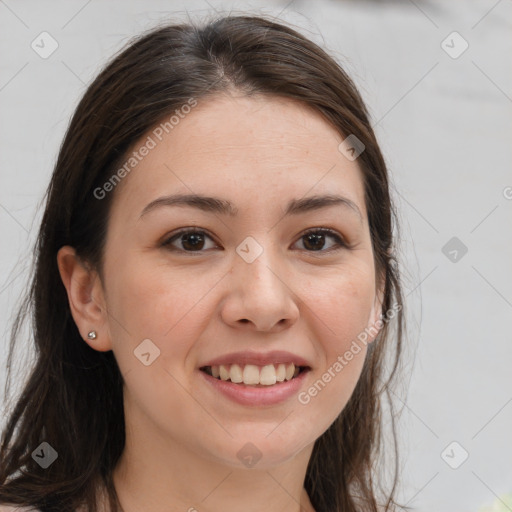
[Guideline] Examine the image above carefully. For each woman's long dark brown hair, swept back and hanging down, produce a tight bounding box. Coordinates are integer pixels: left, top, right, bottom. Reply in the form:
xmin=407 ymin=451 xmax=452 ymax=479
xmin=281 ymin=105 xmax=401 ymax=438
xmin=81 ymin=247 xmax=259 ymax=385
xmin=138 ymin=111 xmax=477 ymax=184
xmin=0 ymin=16 xmax=405 ymax=512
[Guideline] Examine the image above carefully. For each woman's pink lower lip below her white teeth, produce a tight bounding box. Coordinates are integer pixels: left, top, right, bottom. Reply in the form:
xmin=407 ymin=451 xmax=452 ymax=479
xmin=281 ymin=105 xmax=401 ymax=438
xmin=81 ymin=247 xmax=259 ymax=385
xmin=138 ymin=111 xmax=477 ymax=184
xmin=198 ymin=370 xmax=310 ymax=405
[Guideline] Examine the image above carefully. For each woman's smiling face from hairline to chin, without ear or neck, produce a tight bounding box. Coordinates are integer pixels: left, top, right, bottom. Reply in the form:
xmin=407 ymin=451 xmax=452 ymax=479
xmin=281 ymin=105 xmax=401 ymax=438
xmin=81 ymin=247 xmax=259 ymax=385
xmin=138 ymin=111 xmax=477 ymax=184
xmin=91 ymin=96 xmax=380 ymax=468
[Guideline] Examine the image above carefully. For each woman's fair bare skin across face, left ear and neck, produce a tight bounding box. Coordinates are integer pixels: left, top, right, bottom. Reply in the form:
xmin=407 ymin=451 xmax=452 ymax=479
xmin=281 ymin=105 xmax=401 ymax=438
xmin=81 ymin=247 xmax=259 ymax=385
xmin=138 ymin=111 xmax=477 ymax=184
xmin=57 ymin=93 xmax=382 ymax=512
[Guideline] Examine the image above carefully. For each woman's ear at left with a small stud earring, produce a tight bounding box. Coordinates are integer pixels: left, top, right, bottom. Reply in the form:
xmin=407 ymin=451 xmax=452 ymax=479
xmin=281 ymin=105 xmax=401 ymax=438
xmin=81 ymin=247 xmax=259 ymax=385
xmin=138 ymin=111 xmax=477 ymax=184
xmin=57 ymin=245 xmax=112 ymax=352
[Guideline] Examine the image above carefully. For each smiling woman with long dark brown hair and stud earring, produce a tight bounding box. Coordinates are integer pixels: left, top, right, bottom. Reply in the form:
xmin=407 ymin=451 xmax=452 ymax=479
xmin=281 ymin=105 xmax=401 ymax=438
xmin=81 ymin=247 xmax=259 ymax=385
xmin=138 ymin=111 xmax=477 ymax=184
xmin=0 ymin=12 xmax=404 ymax=512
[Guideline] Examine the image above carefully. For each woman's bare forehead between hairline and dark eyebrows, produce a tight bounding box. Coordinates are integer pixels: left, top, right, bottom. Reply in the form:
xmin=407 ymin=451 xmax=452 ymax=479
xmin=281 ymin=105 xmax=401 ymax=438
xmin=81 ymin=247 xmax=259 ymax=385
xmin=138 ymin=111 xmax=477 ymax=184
xmin=113 ymin=95 xmax=366 ymax=224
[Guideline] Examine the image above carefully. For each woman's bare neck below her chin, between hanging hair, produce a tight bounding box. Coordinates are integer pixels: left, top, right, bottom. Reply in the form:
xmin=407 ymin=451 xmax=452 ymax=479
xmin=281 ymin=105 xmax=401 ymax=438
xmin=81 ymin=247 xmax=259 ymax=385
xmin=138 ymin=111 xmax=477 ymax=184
xmin=113 ymin=418 xmax=314 ymax=512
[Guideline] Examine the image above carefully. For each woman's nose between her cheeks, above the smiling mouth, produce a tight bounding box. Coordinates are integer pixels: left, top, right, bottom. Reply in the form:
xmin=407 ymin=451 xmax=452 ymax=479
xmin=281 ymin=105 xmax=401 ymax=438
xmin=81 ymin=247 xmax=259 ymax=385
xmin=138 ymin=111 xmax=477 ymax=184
xmin=221 ymin=243 xmax=299 ymax=332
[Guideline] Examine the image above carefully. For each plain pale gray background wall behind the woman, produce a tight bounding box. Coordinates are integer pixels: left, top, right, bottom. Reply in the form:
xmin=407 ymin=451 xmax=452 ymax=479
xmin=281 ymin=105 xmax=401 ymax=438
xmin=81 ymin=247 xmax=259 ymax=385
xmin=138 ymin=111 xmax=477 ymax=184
xmin=0 ymin=0 xmax=512 ymax=512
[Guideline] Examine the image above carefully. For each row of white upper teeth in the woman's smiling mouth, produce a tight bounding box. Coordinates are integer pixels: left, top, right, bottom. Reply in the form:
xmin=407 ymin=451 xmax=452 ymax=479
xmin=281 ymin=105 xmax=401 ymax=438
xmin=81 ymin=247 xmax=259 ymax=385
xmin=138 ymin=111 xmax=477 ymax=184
xmin=210 ymin=363 xmax=300 ymax=386
